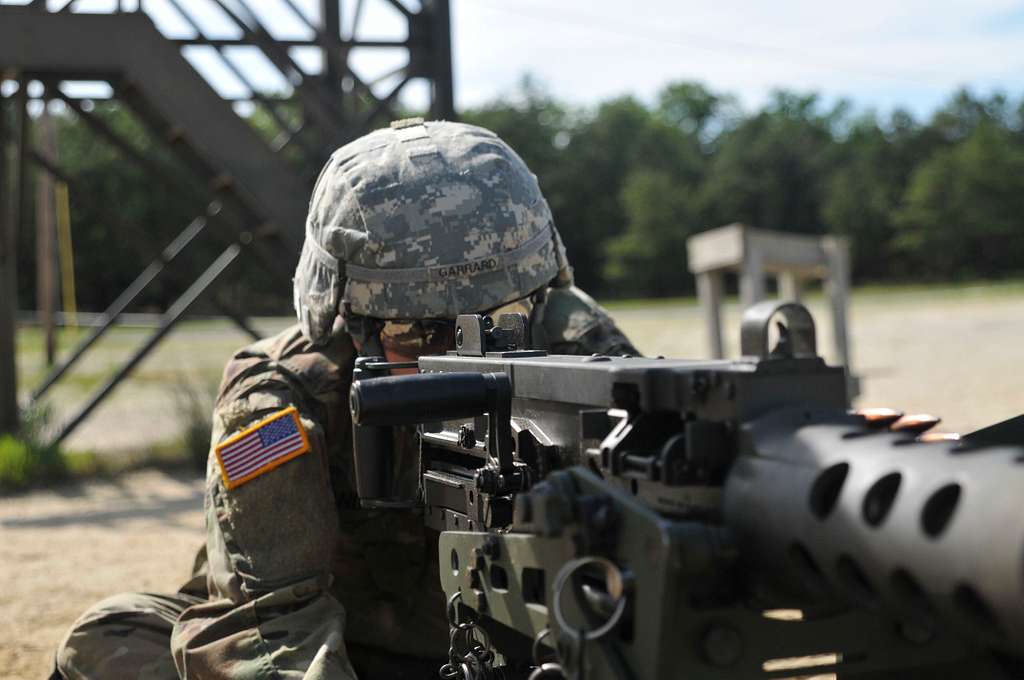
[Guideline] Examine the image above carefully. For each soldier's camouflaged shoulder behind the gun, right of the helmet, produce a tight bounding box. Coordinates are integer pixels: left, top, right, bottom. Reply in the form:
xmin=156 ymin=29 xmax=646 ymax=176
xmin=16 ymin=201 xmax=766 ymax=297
xmin=534 ymin=286 xmax=639 ymax=355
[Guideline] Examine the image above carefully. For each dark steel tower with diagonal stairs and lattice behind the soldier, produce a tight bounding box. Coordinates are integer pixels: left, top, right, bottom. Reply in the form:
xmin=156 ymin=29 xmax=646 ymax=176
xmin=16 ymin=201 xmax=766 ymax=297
xmin=0 ymin=0 xmax=455 ymax=440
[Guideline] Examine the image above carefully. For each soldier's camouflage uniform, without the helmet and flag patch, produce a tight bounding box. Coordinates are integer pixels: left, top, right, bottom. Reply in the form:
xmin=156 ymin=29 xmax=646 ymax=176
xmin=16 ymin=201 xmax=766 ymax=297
xmin=58 ymin=288 xmax=636 ymax=680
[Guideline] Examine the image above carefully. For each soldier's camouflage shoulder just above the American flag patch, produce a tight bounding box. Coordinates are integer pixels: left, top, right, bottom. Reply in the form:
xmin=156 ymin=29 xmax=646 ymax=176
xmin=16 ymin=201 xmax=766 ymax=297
xmin=215 ymin=325 xmax=355 ymax=430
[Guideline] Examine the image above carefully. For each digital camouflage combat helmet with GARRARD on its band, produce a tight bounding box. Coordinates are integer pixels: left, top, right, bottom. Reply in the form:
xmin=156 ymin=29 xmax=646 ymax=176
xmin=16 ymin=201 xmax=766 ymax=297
xmin=295 ymin=119 xmax=571 ymax=342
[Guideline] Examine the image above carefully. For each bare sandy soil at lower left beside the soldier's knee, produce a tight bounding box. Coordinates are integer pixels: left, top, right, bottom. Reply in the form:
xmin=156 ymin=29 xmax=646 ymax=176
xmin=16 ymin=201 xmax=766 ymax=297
xmin=0 ymin=471 xmax=203 ymax=680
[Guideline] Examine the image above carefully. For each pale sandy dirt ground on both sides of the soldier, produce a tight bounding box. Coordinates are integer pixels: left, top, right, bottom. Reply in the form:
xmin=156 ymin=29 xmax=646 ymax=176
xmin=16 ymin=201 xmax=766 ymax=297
xmin=0 ymin=287 xmax=1024 ymax=679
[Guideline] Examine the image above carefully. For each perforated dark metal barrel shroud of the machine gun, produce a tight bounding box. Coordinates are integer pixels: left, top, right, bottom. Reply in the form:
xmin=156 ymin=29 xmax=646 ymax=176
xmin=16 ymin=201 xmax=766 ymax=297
xmin=724 ymin=409 xmax=1024 ymax=653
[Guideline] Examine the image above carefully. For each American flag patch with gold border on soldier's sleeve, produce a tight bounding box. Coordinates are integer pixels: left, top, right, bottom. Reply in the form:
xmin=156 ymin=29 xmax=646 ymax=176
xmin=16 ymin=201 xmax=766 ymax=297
xmin=214 ymin=407 xmax=309 ymax=488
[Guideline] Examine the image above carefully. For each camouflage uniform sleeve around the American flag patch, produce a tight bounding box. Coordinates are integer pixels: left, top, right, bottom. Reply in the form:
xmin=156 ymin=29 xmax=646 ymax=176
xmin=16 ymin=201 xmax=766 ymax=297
xmin=171 ymin=357 xmax=355 ymax=680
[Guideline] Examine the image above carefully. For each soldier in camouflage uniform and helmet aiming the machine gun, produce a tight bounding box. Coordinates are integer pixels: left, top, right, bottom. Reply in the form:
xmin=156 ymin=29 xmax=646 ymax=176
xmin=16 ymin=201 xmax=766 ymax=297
xmin=54 ymin=119 xmax=636 ymax=680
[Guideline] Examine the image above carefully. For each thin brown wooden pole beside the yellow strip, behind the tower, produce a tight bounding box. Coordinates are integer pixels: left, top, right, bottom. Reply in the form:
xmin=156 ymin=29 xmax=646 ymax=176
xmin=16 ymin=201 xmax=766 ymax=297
xmin=36 ymin=109 xmax=57 ymax=366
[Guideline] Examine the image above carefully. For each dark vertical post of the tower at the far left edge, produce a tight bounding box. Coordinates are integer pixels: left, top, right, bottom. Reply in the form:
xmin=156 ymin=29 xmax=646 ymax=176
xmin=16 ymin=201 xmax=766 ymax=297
xmin=0 ymin=74 xmax=28 ymax=432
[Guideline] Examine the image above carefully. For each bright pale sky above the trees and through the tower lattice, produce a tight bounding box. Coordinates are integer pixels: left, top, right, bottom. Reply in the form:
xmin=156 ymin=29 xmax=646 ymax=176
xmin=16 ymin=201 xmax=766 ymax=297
xmin=12 ymin=0 xmax=1024 ymax=116
